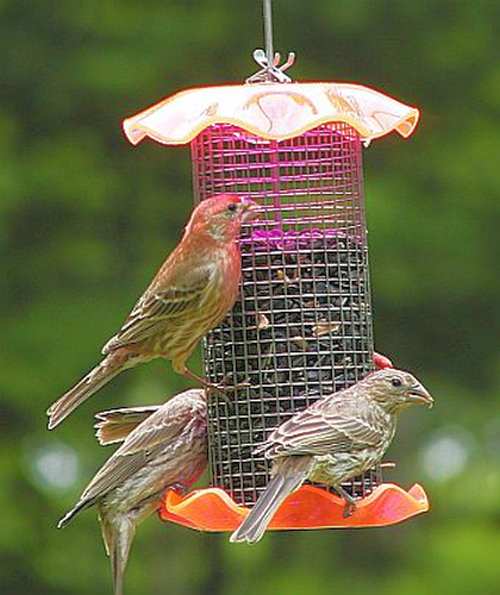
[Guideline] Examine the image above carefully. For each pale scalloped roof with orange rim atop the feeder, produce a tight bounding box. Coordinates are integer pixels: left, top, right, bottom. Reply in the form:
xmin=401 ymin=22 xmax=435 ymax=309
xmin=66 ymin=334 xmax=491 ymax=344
xmin=123 ymin=82 xmax=420 ymax=145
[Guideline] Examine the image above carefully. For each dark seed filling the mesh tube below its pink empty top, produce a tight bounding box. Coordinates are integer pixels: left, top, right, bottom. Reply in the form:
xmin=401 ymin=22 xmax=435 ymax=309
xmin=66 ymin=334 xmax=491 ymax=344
xmin=205 ymin=230 xmax=381 ymax=506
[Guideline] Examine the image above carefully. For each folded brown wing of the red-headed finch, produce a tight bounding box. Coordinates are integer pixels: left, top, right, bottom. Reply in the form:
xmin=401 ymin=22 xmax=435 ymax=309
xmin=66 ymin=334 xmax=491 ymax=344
xmin=102 ymin=265 xmax=214 ymax=355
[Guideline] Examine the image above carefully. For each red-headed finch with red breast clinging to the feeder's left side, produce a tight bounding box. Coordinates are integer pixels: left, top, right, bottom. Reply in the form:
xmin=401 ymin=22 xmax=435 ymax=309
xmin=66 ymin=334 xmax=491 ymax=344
xmin=47 ymin=194 xmax=257 ymax=430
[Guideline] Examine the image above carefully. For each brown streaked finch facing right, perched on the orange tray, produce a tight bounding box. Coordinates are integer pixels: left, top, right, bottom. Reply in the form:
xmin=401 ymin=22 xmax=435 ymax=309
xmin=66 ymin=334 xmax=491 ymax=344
xmin=231 ymin=368 xmax=433 ymax=543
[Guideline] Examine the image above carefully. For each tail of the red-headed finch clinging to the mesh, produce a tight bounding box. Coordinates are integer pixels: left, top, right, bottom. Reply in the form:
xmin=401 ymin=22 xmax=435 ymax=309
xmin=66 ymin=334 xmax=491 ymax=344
xmin=47 ymin=352 xmax=129 ymax=430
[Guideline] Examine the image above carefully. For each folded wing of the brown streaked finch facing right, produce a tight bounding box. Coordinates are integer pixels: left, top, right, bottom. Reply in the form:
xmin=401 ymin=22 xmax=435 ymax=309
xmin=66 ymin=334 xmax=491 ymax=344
xmin=259 ymin=399 xmax=384 ymax=458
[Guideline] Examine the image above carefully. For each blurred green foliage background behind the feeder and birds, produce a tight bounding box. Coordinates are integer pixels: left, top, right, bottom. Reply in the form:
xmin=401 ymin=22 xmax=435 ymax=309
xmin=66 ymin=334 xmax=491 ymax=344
xmin=0 ymin=0 xmax=500 ymax=595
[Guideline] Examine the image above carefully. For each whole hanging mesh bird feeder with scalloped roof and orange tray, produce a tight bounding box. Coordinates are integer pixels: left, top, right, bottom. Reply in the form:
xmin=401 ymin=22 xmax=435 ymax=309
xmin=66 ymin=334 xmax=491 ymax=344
xmin=123 ymin=0 xmax=428 ymax=531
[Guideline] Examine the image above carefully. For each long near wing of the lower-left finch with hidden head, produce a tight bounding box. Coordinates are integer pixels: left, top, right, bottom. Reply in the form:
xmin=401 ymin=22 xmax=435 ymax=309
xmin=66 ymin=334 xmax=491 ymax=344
xmin=80 ymin=398 xmax=206 ymax=501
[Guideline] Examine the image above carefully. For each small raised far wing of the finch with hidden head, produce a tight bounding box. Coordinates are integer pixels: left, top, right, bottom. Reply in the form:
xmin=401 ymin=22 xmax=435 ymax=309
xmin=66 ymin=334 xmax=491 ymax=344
xmin=94 ymin=405 xmax=160 ymax=446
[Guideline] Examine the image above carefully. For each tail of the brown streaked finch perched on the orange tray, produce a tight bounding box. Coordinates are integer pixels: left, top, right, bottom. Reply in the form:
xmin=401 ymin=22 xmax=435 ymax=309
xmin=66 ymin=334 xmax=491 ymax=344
xmin=229 ymin=465 xmax=309 ymax=543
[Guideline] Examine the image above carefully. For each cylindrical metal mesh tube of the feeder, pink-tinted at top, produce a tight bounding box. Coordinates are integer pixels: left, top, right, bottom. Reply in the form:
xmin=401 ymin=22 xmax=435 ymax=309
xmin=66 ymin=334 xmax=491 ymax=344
xmin=191 ymin=123 xmax=381 ymax=506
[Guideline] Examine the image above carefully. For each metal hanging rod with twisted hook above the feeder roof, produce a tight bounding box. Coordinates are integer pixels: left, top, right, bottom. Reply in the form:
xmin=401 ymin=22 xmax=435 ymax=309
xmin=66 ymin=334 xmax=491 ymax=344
xmin=246 ymin=0 xmax=295 ymax=83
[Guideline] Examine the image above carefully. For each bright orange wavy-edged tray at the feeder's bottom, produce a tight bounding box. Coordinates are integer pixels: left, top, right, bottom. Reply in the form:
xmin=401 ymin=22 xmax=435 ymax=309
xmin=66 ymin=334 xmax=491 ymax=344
xmin=159 ymin=483 xmax=429 ymax=531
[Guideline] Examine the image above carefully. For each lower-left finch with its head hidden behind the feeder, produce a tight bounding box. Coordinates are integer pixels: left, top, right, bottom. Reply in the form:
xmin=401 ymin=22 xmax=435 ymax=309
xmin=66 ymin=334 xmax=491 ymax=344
xmin=57 ymin=389 xmax=208 ymax=595
